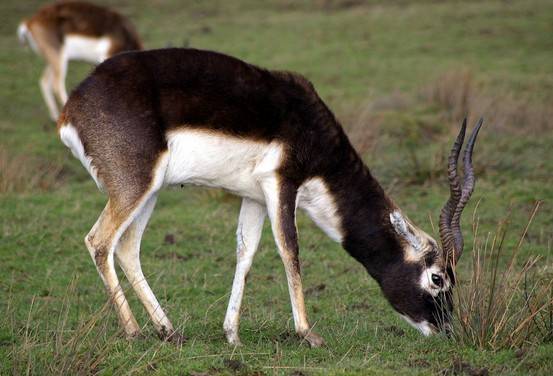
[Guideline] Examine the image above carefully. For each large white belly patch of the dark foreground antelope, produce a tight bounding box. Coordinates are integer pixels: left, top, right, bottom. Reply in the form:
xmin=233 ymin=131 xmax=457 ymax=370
xmin=165 ymin=130 xmax=280 ymax=202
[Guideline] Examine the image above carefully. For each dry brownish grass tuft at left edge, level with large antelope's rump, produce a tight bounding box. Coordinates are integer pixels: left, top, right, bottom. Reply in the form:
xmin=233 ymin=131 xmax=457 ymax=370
xmin=0 ymin=146 xmax=63 ymax=194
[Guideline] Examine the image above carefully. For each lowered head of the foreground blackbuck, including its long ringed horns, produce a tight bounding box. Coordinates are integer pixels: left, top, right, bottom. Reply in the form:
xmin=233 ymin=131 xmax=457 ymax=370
xmin=380 ymin=119 xmax=482 ymax=335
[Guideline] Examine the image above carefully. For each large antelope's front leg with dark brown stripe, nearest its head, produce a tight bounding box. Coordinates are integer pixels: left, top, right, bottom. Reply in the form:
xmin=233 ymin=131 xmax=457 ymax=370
xmin=262 ymin=176 xmax=324 ymax=347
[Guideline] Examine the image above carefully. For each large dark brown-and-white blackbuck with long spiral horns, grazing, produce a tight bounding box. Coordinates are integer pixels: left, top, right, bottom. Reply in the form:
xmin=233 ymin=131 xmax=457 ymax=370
xmin=58 ymin=49 xmax=481 ymax=346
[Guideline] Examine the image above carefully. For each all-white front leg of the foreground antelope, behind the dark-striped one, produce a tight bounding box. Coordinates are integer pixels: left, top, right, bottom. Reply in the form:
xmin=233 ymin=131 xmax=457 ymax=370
xmin=223 ymin=198 xmax=267 ymax=346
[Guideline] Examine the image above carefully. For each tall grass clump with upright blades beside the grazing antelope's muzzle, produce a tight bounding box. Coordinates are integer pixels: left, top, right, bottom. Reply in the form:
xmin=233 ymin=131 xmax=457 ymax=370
xmin=453 ymin=202 xmax=553 ymax=350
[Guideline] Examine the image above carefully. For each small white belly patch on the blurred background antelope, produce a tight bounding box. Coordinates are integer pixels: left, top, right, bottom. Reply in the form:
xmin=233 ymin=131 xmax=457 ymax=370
xmin=63 ymin=35 xmax=111 ymax=64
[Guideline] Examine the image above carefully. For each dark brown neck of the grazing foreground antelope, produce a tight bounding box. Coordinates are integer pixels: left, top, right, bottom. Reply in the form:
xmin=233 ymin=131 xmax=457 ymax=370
xmin=280 ymin=84 xmax=402 ymax=281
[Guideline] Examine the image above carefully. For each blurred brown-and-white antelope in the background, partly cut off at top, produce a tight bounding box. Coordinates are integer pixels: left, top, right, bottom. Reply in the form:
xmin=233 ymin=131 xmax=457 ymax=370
xmin=17 ymin=1 xmax=142 ymax=121
